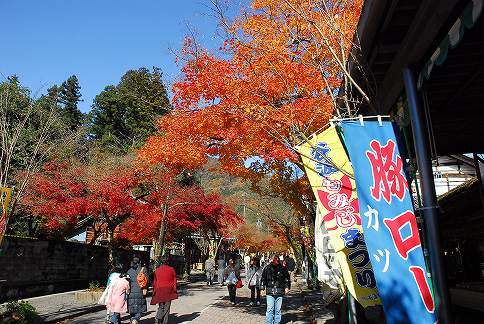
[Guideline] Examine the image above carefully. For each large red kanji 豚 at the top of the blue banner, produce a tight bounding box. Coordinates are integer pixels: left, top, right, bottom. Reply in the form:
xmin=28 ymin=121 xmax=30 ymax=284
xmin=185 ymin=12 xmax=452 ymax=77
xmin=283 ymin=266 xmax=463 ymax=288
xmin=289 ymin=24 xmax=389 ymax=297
xmin=366 ymin=140 xmax=408 ymax=204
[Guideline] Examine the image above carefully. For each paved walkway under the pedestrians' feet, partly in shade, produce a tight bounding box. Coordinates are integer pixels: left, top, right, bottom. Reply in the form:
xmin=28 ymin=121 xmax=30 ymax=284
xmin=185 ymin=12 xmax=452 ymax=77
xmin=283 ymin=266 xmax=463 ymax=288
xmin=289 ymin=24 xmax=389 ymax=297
xmin=21 ymin=274 xmax=332 ymax=324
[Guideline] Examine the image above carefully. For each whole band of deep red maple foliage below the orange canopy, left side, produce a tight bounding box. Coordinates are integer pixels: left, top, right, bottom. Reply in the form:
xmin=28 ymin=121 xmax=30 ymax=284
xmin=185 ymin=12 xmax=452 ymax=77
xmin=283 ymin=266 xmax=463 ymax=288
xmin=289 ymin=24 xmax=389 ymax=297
xmin=23 ymin=161 xmax=242 ymax=251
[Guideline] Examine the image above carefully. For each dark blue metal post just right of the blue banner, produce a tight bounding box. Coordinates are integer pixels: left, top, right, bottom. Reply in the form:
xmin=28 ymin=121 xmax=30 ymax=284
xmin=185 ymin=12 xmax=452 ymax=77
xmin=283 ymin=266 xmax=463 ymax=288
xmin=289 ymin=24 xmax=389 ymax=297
xmin=403 ymin=67 xmax=452 ymax=324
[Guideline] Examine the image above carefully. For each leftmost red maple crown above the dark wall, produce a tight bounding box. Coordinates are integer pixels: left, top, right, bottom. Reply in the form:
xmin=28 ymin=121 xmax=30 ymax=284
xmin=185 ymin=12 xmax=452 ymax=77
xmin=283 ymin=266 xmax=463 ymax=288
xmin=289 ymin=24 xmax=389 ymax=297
xmin=23 ymin=163 xmax=148 ymax=236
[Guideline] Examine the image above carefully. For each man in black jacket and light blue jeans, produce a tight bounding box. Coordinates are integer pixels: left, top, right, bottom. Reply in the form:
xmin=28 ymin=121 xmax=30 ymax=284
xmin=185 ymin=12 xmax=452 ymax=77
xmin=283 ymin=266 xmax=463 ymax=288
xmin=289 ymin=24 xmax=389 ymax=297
xmin=261 ymin=256 xmax=291 ymax=324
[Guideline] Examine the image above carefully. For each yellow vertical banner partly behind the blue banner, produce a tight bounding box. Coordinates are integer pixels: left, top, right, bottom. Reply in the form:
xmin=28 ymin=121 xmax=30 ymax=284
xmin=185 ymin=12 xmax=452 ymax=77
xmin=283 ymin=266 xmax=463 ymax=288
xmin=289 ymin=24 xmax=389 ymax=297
xmin=298 ymin=126 xmax=381 ymax=307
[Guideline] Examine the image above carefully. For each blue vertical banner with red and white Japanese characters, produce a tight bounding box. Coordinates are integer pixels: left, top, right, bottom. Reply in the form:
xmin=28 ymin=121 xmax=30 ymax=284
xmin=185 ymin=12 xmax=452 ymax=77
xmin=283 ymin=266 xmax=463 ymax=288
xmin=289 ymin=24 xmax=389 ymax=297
xmin=341 ymin=121 xmax=437 ymax=324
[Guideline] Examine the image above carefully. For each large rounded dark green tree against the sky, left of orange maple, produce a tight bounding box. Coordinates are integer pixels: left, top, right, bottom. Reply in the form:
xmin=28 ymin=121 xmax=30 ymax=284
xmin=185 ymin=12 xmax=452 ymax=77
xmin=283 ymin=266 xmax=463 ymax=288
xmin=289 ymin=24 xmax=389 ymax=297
xmin=90 ymin=67 xmax=170 ymax=150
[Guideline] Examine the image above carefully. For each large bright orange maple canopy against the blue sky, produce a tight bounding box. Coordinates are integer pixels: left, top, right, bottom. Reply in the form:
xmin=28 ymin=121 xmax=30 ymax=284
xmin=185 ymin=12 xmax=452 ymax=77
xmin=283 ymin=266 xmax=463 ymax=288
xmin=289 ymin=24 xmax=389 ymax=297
xmin=140 ymin=0 xmax=361 ymax=174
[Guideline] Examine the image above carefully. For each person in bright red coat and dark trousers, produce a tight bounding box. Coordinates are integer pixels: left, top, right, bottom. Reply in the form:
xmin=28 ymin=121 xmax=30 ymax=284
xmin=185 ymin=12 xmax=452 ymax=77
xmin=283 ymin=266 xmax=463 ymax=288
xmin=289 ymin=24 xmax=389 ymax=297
xmin=151 ymin=255 xmax=178 ymax=324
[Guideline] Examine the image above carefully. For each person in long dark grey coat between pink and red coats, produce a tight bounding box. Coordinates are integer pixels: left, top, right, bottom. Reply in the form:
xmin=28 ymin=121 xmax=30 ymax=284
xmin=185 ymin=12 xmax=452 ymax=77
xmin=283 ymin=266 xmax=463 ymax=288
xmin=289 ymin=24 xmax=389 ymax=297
xmin=128 ymin=257 xmax=148 ymax=324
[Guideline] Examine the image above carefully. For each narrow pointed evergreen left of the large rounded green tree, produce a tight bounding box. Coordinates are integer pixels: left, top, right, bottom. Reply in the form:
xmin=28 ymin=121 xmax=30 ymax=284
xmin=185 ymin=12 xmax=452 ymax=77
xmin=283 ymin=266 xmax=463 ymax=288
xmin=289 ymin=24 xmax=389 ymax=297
xmin=59 ymin=75 xmax=84 ymax=130
